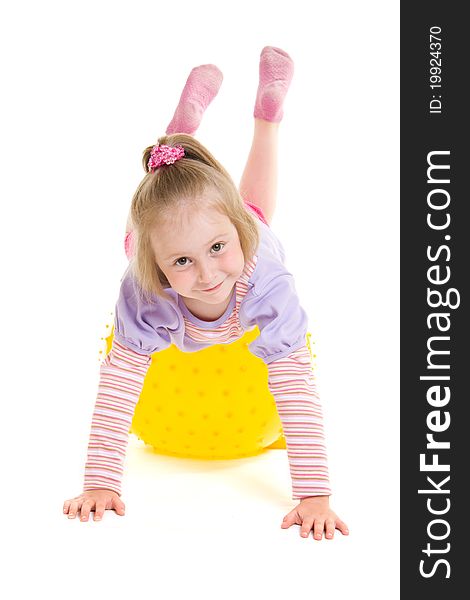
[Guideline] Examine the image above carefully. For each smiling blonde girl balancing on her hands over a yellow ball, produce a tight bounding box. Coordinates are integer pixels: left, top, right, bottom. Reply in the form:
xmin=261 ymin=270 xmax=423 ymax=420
xmin=63 ymin=47 xmax=348 ymax=540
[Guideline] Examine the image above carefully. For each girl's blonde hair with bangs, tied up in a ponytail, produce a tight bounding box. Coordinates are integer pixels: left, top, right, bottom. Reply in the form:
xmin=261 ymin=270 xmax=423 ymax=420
xmin=130 ymin=133 xmax=259 ymax=302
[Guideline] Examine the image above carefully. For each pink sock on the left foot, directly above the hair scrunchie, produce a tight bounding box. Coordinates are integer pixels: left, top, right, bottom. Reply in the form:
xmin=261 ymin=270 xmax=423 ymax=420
xmin=166 ymin=65 xmax=223 ymax=135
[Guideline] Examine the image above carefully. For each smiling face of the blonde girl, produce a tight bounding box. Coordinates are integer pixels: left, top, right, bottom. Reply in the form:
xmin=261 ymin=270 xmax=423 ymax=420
xmin=151 ymin=207 xmax=245 ymax=304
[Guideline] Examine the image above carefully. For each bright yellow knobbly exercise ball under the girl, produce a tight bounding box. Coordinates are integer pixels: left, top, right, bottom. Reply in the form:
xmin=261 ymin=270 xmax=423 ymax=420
xmin=106 ymin=328 xmax=286 ymax=459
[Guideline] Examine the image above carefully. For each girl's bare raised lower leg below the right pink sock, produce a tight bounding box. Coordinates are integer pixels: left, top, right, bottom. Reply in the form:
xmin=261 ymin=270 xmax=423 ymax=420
xmin=239 ymin=119 xmax=279 ymax=223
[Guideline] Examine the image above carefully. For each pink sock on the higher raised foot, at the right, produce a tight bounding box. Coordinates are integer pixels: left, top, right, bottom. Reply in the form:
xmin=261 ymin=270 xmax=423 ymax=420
xmin=253 ymin=46 xmax=294 ymax=123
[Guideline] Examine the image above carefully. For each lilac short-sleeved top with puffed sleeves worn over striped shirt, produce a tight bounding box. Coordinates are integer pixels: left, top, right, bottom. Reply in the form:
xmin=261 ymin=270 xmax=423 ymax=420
xmin=114 ymin=220 xmax=308 ymax=364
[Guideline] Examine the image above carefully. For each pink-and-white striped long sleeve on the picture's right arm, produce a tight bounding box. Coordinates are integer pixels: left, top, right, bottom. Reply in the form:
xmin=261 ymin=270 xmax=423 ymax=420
xmin=267 ymin=346 xmax=331 ymax=500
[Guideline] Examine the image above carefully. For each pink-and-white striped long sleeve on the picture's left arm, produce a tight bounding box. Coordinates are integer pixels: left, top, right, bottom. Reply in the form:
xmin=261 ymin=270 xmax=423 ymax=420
xmin=83 ymin=339 xmax=152 ymax=495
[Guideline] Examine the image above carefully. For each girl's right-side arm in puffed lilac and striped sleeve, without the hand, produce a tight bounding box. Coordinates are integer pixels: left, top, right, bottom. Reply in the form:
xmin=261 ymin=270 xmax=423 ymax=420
xmin=240 ymin=266 xmax=331 ymax=499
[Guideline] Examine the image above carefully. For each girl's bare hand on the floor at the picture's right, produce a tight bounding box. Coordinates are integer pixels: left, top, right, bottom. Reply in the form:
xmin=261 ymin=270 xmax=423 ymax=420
xmin=281 ymin=496 xmax=349 ymax=540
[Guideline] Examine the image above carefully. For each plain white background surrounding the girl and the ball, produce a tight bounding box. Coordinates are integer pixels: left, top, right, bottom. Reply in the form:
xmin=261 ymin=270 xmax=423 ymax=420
xmin=0 ymin=0 xmax=398 ymax=599
